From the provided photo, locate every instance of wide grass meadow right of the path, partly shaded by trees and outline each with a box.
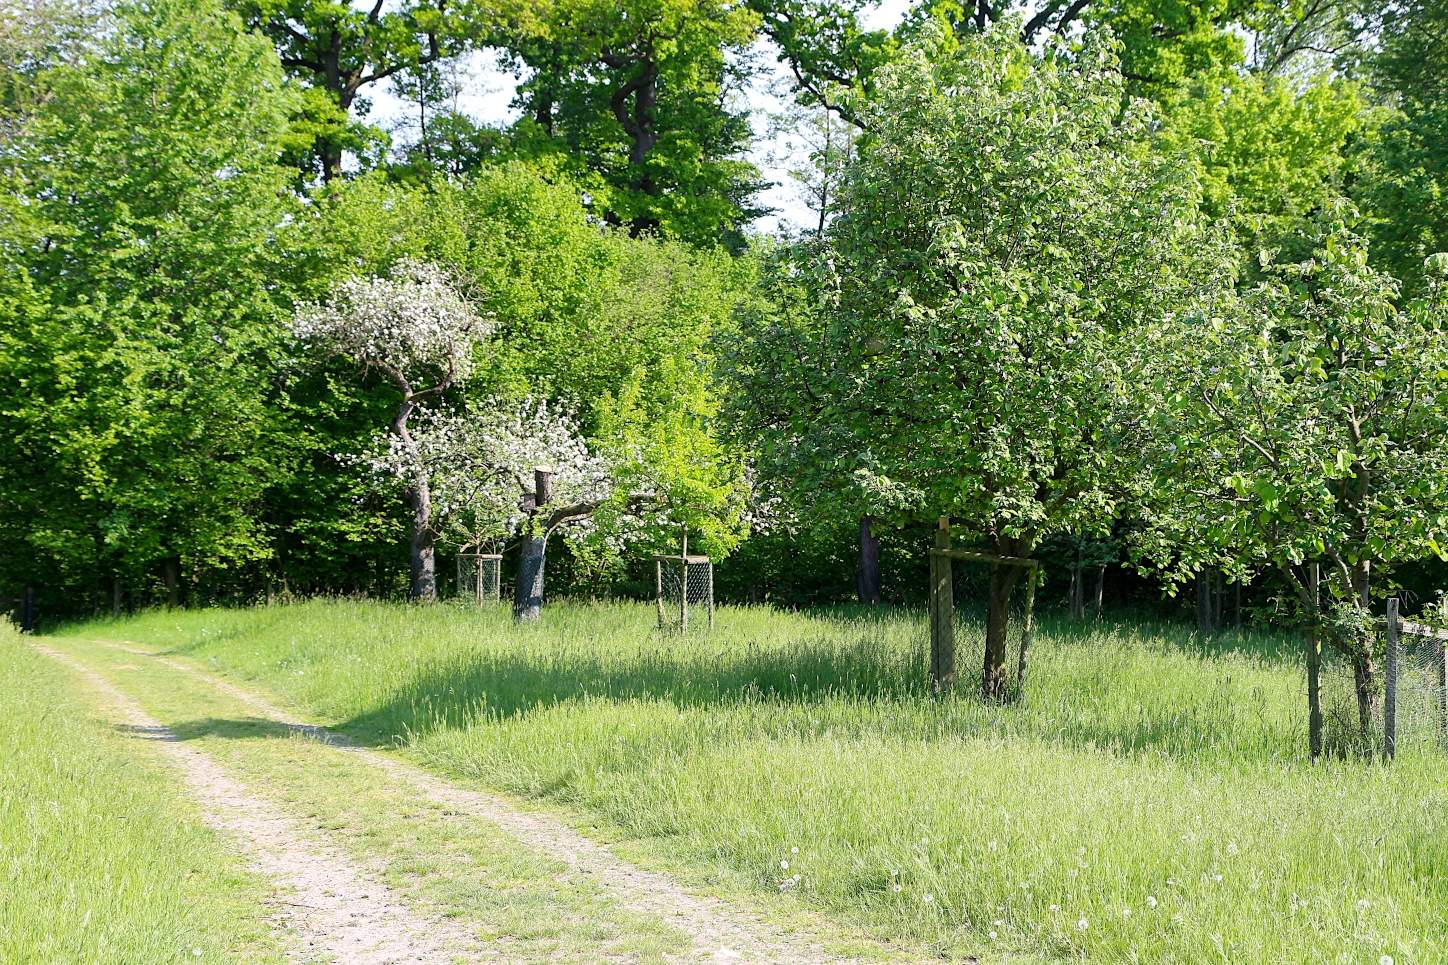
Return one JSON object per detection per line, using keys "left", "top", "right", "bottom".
{"left": 71, "top": 603, "right": 1448, "bottom": 964}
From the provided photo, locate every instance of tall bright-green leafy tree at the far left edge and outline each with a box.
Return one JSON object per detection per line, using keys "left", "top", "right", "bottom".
{"left": 0, "top": 0, "right": 292, "bottom": 605}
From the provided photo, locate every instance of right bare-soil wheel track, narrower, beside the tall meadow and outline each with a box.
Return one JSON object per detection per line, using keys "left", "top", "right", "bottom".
{"left": 68, "top": 640, "right": 857, "bottom": 965}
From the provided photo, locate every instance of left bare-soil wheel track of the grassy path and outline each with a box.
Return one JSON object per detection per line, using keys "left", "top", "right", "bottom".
{"left": 35, "top": 645, "right": 500, "bottom": 965}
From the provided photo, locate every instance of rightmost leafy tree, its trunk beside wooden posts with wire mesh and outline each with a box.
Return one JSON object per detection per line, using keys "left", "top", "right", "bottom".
{"left": 1140, "top": 225, "right": 1448, "bottom": 755}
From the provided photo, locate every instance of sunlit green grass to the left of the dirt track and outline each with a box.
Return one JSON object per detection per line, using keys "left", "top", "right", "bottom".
{"left": 0, "top": 623, "right": 282, "bottom": 965}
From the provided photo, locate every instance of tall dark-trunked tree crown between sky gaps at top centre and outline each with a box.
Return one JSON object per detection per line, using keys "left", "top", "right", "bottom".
{"left": 497, "top": 0, "right": 760, "bottom": 245}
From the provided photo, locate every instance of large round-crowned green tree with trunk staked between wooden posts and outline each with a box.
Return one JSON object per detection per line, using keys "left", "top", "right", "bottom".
{"left": 729, "top": 26, "right": 1219, "bottom": 697}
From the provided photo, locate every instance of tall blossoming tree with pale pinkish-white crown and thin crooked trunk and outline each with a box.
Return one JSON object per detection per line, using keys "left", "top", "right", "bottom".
{"left": 292, "top": 261, "right": 492, "bottom": 601}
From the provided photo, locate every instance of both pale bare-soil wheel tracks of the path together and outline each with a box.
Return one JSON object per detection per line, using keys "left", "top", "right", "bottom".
{"left": 36, "top": 640, "right": 873, "bottom": 965}
